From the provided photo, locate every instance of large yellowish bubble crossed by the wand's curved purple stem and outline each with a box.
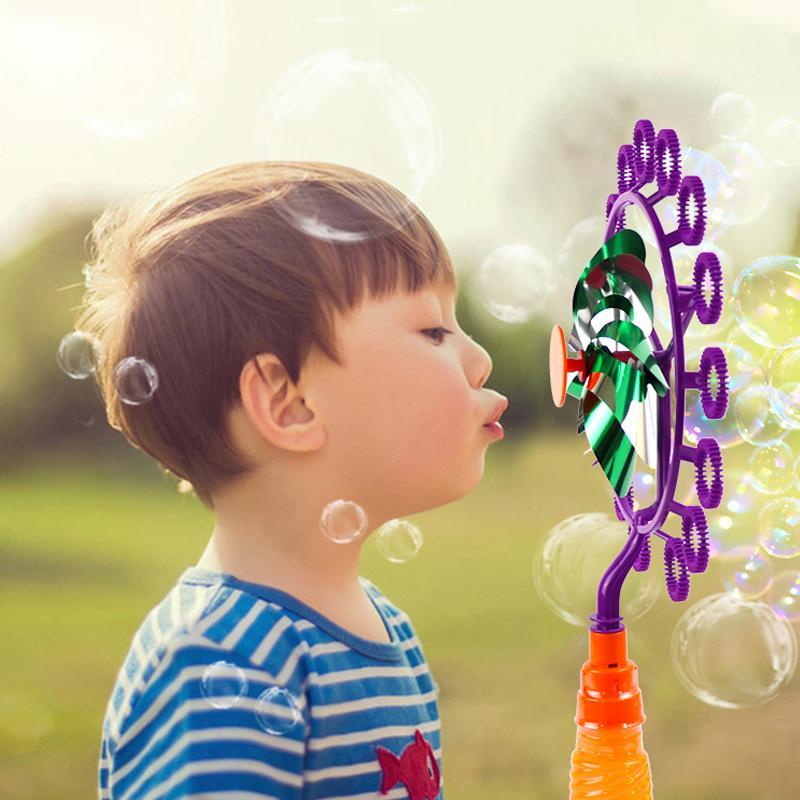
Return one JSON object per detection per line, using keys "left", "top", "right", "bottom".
{"left": 533, "top": 512, "right": 661, "bottom": 627}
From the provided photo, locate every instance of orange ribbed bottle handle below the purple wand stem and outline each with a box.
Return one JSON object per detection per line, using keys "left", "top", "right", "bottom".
{"left": 569, "top": 628, "right": 653, "bottom": 800}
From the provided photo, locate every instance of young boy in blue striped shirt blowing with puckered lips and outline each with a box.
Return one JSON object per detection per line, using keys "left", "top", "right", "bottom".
{"left": 76, "top": 162, "right": 507, "bottom": 800}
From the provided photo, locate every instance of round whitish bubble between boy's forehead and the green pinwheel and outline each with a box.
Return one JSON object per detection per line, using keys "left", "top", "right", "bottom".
{"left": 476, "top": 244, "right": 554, "bottom": 323}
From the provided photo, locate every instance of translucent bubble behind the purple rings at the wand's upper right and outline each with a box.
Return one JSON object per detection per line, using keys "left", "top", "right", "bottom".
{"left": 625, "top": 146, "right": 731, "bottom": 245}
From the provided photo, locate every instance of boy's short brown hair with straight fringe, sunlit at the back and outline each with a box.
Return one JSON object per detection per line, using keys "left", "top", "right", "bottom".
{"left": 75, "top": 161, "right": 456, "bottom": 509}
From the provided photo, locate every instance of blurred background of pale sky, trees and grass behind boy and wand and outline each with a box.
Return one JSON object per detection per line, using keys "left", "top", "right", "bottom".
{"left": 0, "top": 0, "right": 800, "bottom": 800}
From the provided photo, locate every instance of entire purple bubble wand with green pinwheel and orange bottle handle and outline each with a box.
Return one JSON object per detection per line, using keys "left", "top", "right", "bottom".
{"left": 550, "top": 119, "right": 728, "bottom": 800}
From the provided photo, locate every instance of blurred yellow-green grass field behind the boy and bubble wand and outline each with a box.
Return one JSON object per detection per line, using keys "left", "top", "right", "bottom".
{"left": 0, "top": 434, "right": 800, "bottom": 800}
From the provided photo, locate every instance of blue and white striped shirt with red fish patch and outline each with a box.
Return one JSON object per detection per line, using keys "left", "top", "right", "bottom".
{"left": 99, "top": 566, "right": 444, "bottom": 800}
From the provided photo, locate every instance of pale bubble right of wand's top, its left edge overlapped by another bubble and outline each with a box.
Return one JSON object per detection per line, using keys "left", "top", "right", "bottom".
{"left": 709, "top": 142, "right": 771, "bottom": 226}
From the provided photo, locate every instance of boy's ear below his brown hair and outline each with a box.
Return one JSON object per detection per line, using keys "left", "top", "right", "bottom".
{"left": 239, "top": 353, "right": 327, "bottom": 452}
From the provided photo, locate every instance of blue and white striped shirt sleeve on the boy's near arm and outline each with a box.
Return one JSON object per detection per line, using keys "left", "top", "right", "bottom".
{"left": 109, "top": 635, "right": 309, "bottom": 800}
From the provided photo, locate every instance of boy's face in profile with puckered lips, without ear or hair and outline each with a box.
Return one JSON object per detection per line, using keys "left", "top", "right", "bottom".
{"left": 305, "top": 286, "right": 505, "bottom": 518}
